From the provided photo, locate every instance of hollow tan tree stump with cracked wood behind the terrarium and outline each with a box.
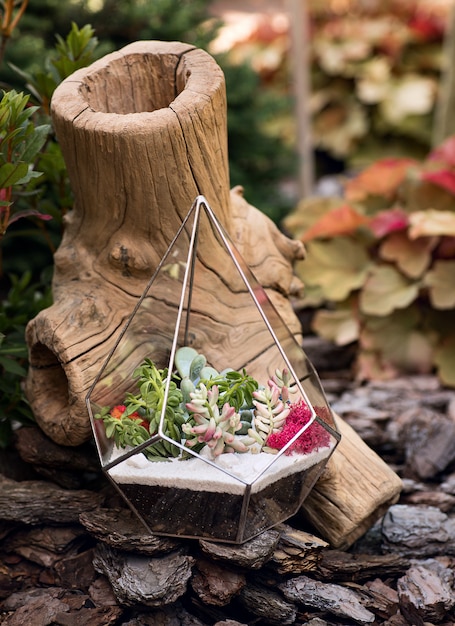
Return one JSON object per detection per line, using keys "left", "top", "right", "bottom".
{"left": 26, "top": 41, "right": 400, "bottom": 544}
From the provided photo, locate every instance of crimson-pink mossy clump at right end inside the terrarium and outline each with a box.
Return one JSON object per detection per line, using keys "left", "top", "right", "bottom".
{"left": 267, "top": 400, "right": 330, "bottom": 455}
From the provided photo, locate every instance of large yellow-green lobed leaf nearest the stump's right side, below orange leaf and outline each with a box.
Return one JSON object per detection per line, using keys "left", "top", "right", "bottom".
{"left": 299, "top": 237, "right": 370, "bottom": 301}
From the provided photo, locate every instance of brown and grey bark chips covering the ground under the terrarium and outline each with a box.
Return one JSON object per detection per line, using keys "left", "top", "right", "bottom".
{"left": 0, "top": 342, "right": 455, "bottom": 626}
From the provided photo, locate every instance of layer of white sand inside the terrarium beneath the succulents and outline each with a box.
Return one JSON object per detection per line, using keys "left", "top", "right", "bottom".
{"left": 108, "top": 446, "right": 333, "bottom": 494}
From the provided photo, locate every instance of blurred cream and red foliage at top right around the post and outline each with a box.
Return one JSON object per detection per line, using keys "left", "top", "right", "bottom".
{"left": 216, "top": 0, "right": 454, "bottom": 178}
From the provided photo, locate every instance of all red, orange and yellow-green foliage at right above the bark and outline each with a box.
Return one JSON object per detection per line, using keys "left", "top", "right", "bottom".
{"left": 211, "top": 0, "right": 455, "bottom": 387}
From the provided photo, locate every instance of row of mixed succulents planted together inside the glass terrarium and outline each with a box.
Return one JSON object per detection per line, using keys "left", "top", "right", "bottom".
{"left": 95, "top": 346, "right": 324, "bottom": 460}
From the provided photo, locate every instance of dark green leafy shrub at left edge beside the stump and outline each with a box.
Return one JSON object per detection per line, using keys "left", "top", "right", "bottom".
{"left": 0, "top": 24, "right": 100, "bottom": 447}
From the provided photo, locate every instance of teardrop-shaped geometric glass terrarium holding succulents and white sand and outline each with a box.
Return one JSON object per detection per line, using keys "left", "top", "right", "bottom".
{"left": 87, "top": 196, "right": 340, "bottom": 543}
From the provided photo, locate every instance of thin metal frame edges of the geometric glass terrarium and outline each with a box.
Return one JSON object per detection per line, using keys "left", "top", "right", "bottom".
{"left": 86, "top": 196, "right": 340, "bottom": 543}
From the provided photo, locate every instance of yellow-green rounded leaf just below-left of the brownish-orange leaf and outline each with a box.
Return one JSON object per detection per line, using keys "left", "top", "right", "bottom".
{"left": 359, "top": 265, "right": 419, "bottom": 316}
